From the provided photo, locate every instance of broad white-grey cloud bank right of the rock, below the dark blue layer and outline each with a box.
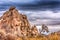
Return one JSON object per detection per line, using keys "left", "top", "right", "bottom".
{"left": 19, "top": 11, "right": 60, "bottom": 25}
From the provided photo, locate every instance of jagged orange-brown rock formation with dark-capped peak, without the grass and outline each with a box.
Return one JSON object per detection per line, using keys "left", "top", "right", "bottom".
{"left": 0, "top": 6, "right": 38, "bottom": 39}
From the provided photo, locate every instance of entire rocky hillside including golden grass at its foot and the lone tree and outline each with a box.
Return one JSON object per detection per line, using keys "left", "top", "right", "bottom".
{"left": 0, "top": 6, "right": 60, "bottom": 40}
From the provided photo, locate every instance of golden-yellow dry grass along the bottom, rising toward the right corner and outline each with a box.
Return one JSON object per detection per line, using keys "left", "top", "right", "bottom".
{"left": 17, "top": 33, "right": 60, "bottom": 40}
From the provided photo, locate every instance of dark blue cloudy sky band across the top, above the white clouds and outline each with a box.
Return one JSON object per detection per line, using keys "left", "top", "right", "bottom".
{"left": 0, "top": 0, "right": 60, "bottom": 10}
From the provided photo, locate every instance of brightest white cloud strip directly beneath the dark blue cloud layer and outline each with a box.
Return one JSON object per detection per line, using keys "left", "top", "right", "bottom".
{"left": 21, "top": 11, "right": 60, "bottom": 19}
